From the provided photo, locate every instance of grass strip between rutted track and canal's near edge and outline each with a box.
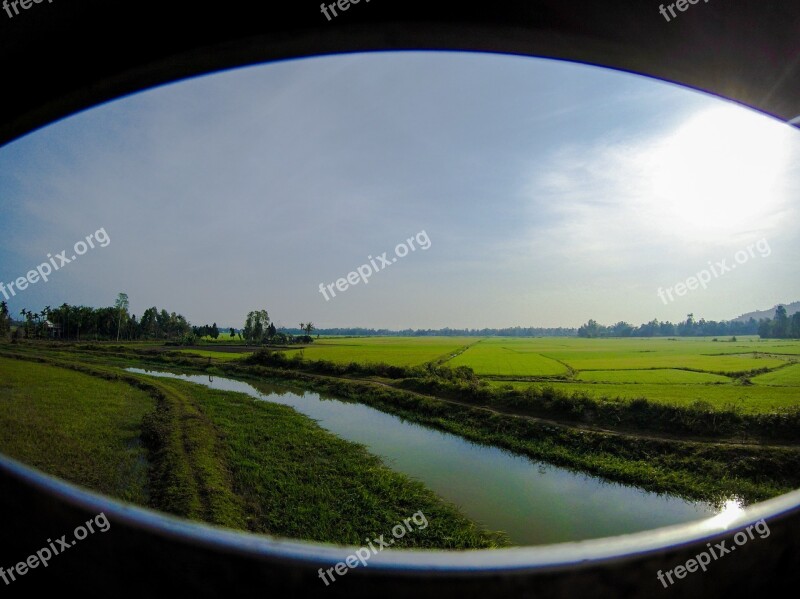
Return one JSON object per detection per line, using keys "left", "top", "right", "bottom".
{"left": 165, "top": 380, "right": 506, "bottom": 549}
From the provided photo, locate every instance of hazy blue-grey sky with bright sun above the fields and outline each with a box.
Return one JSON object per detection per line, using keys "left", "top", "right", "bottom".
{"left": 0, "top": 52, "right": 800, "bottom": 328}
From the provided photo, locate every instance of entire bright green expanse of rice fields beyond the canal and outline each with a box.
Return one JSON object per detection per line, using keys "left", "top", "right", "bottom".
{"left": 245, "top": 337, "right": 800, "bottom": 412}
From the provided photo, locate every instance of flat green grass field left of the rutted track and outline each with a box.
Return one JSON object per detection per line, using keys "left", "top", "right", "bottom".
{"left": 0, "top": 358, "right": 155, "bottom": 504}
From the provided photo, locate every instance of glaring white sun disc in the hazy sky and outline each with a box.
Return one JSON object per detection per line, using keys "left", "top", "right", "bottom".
{"left": 650, "top": 105, "right": 796, "bottom": 233}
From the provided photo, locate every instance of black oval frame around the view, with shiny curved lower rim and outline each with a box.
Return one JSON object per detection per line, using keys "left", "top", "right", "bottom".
{"left": 0, "top": 0, "right": 800, "bottom": 598}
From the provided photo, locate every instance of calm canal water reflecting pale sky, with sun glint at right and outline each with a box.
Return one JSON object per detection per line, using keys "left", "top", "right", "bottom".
{"left": 130, "top": 369, "right": 720, "bottom": 545}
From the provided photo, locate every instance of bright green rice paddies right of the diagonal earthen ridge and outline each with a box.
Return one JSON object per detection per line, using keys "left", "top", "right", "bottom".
{"left": 449, "top": 337, "right": 800, "bottom": 413}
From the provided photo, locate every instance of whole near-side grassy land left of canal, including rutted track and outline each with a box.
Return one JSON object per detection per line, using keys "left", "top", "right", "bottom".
{"left": 0, "top": 347, "right": 500, "bottom": 549}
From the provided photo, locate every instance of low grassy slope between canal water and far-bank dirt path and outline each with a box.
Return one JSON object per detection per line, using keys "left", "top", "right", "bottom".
{"left": 221, "top": 363, "right": 800, "bottom": 503}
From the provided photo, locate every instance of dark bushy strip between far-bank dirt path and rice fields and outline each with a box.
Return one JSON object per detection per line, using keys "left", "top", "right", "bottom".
{"left": 238, "top": 350, "right": 800, "bottom": 443}
